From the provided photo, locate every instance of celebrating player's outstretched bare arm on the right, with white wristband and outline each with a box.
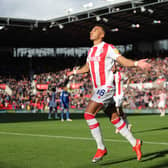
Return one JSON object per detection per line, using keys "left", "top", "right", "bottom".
{"left": 117, "top": 56, "right": 151, "bottom": 70}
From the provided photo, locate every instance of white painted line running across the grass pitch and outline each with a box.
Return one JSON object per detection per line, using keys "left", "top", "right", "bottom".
{"left": 0, "top": 132, "right": 168, "bottom": 145}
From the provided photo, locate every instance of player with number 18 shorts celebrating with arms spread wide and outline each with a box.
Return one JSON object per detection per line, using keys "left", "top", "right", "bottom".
{"left": 68, "top": 25, "right": 151, "bottom": 163}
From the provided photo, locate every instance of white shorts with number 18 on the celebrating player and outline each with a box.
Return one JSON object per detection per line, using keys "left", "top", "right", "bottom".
{"left": 91, "top": 85, "right": 115, "bottom": 105}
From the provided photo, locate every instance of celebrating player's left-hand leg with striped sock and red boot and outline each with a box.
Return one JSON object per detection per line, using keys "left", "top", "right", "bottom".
{"left": 84, "top": 100, "right": 107, "bottom": 163}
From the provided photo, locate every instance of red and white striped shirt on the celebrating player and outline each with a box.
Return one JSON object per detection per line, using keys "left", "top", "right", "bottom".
{"left": 87, "top": 42, "right": 120, "bottom": 89}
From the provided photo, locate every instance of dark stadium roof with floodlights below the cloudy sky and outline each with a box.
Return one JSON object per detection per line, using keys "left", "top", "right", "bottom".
{"left": 0, "top": 0, "right": 168, "bottom": 47}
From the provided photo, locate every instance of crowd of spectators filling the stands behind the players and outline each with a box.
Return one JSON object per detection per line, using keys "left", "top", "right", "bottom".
{"left": 0, "top": 53, "right": 168, "bottom": 112}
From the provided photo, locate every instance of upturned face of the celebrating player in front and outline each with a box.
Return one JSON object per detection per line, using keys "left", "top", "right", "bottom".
{"left": 90, "top": 26, "right": 104, "bottom": 41}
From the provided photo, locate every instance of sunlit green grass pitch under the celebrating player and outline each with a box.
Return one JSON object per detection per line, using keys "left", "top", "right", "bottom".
{"left": 0, "top": 115, "right": 168, "bottom": 168}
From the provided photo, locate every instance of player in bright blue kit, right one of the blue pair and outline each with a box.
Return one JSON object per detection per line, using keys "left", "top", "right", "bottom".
{"left": 60, "top": 86, "right": 72, "bottom": 121}
